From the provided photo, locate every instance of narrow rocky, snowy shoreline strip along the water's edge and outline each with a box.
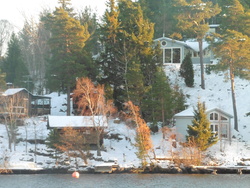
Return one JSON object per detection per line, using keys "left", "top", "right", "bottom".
{"left": 0, "top": 166, "right": 250, "bottom": 175}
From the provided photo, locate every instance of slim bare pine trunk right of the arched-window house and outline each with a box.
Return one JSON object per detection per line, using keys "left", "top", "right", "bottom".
{"left": 230, "top": 62, "right": 239, "bottom": 131}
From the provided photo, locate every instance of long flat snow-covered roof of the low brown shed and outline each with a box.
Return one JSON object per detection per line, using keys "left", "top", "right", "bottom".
{"left": 48, "top": 116, "right": 108, "bottom": 128}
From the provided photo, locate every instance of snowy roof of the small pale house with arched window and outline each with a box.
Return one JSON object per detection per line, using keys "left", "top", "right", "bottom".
{"left": 174, "top": 108, "right": 233, "bottom": 118}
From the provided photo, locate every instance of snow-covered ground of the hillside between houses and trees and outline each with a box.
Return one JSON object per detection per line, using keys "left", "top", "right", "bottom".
{"left": 0, "top": 66, "right": 250, "bottom": 168}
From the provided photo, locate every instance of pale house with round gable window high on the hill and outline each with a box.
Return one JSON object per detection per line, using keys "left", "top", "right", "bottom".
{"left": 154, "top": 36, "right": 213, "bottom": 65}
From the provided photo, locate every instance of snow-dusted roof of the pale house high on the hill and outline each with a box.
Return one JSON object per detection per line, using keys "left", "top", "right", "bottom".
{"left": 154, "top": 37, "right": 209, "bottom": 52}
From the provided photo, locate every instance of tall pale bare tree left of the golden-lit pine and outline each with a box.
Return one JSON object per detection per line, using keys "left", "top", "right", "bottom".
{"left": 19, "top": 9, "right": 49, "bottom": 94}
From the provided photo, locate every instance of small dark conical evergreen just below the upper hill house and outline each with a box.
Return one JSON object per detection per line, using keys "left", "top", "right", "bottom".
{"left": 180, "top": 53, "right": 194, "bottom": 87}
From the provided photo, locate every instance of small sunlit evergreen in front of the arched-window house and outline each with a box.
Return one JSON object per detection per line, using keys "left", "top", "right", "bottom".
{"left": 187, "top": 102, "right": 218, "bottom": 151}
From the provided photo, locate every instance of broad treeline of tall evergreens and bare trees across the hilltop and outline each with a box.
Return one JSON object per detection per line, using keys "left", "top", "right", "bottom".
{"left": 0, "top": 0, "right": 250, "bottom": 124}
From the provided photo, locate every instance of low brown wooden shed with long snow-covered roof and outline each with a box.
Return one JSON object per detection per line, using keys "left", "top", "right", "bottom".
{"left": 47, "top": 116, "right": 108, "bottom": 145}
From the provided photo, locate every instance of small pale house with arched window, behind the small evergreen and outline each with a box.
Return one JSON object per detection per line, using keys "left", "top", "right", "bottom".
{"left": 174, "top": 108, "right": 233, "bottom": 141}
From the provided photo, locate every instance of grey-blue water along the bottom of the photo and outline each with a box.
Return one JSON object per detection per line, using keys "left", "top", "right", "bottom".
{"left": 0, "top": 174, "right": 250, "bottom": 188}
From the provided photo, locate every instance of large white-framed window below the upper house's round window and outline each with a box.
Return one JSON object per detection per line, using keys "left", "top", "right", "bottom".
{"left": 165, "top": 48, "right": 181, "bottom": 63}
